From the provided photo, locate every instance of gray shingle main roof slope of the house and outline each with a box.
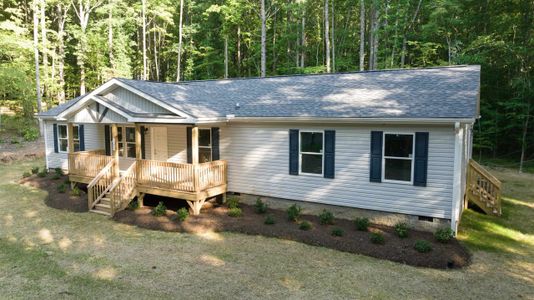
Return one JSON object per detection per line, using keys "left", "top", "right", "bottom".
{"left": 38, "top": 66, "right": 480, "bottom": 118}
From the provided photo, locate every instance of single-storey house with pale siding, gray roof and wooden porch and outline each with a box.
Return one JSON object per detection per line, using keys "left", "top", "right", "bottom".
{"left": 39, "top": 66, "right": 502, "bottom": 230}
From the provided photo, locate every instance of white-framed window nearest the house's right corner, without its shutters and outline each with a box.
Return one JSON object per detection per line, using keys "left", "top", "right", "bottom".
{"left": 382, "top": 133, "right": 414, "bottom": 183}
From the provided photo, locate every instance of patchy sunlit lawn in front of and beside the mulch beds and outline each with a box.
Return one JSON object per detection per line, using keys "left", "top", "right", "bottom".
{"left": 0, "top": 160, "right": 534, "bottom": 299}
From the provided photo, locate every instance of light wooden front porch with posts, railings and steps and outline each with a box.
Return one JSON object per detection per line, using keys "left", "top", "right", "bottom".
{"left": 68, "top": 123, "right": 227, "bottom": 216}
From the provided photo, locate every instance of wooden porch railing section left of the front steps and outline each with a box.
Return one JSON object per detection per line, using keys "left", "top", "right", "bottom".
{"left": 69, "top": 150, "right": 113, "bottom": 177}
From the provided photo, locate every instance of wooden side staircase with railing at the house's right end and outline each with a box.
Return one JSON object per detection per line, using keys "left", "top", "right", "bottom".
{"left": 465, "top": 160, "right": 502, "bottom": 216}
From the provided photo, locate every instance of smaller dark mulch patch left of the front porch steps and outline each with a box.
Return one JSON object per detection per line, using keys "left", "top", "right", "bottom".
{"left": 19, "top": 172, "right": 88, "bottom": 212}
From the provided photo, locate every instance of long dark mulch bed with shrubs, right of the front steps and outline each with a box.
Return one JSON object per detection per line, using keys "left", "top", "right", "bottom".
{"left": 114, "top": 202, "right": 470, "bottom": 269}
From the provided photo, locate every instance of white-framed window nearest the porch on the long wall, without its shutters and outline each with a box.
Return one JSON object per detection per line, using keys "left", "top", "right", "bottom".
{"left": 299, "top": 131, "right": 324, "bottom": 175}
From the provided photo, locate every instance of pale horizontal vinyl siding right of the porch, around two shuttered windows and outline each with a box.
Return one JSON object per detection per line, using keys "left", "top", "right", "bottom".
{"left": 220, "top": 124, "right": 454, "bottom": 218}
